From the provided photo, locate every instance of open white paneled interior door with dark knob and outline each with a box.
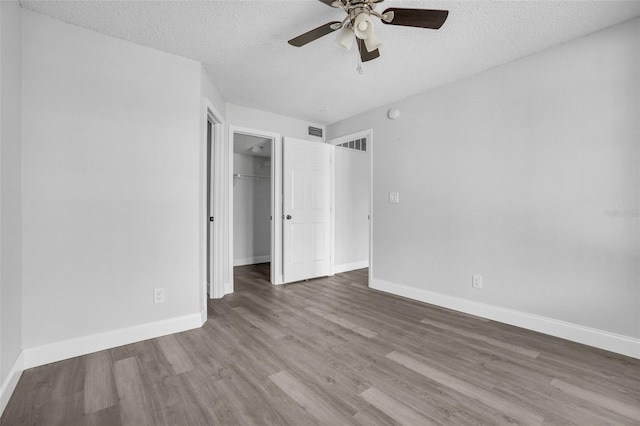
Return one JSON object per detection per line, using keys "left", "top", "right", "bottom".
{"left": 282, "top": 138, "right": 333, "bottom": 282}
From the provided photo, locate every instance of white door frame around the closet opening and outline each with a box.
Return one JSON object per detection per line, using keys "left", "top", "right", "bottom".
{"left": 226, "top": 126, "right": 283, "bottom": 293}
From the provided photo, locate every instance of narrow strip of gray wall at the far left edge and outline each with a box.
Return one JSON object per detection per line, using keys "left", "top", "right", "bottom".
{"left": 0, "top": 1, "right": 22, "bottom": 388}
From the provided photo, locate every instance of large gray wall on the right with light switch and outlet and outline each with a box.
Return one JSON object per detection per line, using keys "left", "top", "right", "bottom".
{"left": 328, "top": 19, "right": 640, "bottom": 338}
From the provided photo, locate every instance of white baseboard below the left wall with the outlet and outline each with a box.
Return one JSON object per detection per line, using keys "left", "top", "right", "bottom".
{"left": 23, "top": 310, "right": 207, "bottom": 369}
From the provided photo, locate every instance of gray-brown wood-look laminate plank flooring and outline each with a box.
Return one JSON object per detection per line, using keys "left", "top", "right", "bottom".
{"left": 0, "top": 264, "right": 640, "bottom": 426}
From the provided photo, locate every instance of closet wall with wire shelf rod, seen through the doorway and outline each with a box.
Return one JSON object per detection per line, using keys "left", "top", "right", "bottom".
{"left": 233, "top": 154, "right": 271, "bottom": 266}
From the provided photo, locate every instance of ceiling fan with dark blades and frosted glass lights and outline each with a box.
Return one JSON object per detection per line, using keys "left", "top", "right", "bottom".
{"left": 289, "top": 0, "right": 449, "bottom": 62}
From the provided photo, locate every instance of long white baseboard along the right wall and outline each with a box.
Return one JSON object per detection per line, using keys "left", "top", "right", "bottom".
{"left": 370, "top": 279, "right": 640, "bottom": 359}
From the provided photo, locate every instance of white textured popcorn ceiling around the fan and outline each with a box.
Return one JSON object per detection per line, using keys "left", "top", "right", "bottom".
{"left": 22, "top": 0, "right": 640, "bottom": 124}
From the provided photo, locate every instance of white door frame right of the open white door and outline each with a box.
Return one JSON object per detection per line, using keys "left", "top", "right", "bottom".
{"left": 327, "top": 129, "right": 373, "bottom": 287}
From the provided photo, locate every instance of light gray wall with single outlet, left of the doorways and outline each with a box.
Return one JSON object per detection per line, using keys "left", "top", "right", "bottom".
{"left": 22, "top": 11, "right": 202, "bottom": 348}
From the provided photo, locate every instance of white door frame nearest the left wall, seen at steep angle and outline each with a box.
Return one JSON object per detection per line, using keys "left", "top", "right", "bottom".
{"left": 205, "top": 98, "right": 225, "bottom": 304}
